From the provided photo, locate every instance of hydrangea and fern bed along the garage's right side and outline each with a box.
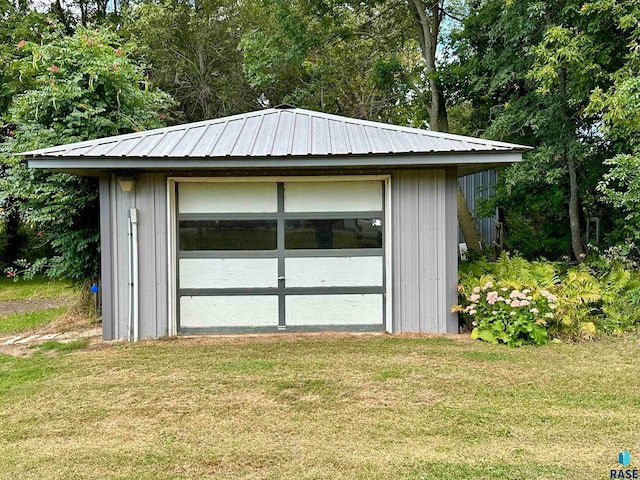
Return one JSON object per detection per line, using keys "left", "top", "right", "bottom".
{"left": 452, "top": 253, "right": 640, "bottom": 346}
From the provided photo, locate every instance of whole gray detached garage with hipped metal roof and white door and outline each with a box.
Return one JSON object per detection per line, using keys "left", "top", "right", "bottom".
{"left": 25, "top": 105, "right": 526, "bottom": 340}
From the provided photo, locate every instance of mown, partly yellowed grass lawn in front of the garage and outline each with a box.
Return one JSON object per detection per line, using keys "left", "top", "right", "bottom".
{"left": 0, "top": 335, "right": 640, "bottom": 480}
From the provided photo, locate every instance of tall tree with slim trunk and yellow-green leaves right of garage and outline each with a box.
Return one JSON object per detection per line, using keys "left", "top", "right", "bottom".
{"left": 450, "top": 0, "right": 626, "bottom": 261}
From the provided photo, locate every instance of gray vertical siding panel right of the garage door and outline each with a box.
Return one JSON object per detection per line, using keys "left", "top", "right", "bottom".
{"left": 391, "top": 169, "right": 458, "bottom": 333}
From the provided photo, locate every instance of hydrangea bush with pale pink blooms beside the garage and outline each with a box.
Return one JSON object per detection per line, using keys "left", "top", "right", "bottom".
{"left": 453, "top": 281, "right": 558, "bottom": 347}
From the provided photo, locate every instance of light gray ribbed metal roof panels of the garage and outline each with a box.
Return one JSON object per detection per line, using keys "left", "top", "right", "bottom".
{"left": 22, "top": 105, "right": 529, "bottom": 160}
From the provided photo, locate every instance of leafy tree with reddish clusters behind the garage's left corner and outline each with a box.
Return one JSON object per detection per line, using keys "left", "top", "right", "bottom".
{"left": 0, "top": 25, "right": 171, "bottom": 280}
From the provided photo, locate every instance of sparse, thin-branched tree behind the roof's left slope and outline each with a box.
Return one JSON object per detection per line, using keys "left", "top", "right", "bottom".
{"left": 123, "top": 0, "right": 258, "bottom": 121}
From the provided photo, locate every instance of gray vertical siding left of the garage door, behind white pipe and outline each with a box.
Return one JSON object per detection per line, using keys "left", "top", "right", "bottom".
{"left": 100, "top": 173, "right": 168, "bottom": 339}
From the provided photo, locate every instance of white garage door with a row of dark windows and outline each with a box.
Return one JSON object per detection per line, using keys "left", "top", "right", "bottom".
{"left": 176, "top": 180, "right": 385, "bottom": 333}
